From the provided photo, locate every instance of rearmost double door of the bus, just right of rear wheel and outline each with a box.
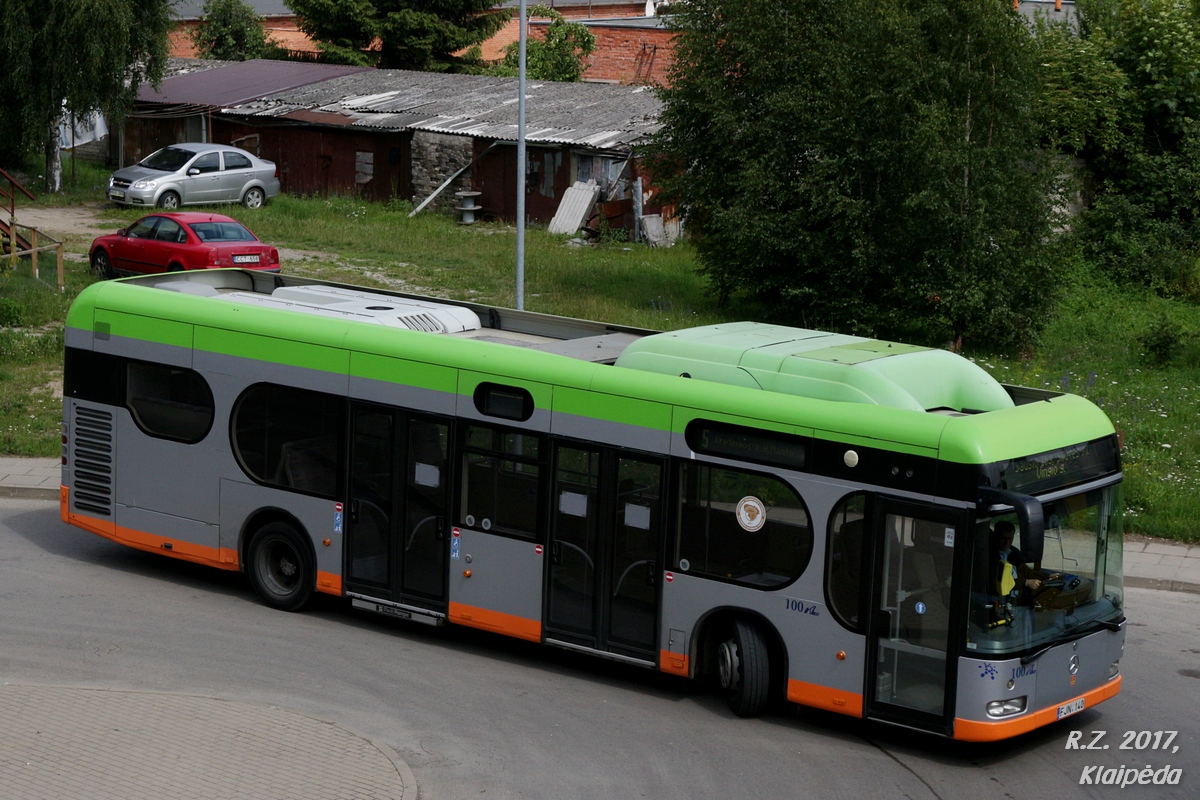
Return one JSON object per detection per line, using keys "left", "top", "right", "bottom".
{"left": 347, "top": 405, "right": 450, "bottom": 612}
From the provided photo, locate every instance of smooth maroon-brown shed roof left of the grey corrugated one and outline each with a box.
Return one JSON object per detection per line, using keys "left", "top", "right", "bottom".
{"left": 138, "top": 60, "right": 371, "bottom": 108}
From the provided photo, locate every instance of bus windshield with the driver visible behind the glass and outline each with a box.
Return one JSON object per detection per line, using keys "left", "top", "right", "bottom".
{"left": 966, "top": 487, "right": 1123, "bottom": 655}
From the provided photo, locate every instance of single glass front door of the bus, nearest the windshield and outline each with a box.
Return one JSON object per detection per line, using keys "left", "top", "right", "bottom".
{"left": 865, "top": 499, "right": 970, "bottom": 734}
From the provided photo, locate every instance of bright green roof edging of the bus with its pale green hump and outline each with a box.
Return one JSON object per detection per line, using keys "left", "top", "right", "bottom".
{"left": 66, "top": 270, "right": 1112, "bottom": 463}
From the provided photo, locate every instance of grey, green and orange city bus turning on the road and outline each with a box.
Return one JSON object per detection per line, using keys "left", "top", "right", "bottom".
{"left": 60, "top": 270, "right": 1126, "bottom": 741}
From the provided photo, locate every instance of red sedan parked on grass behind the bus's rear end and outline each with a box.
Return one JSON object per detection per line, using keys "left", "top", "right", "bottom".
{"left": 91, "top": 211, "right": 280, "bottom": 278}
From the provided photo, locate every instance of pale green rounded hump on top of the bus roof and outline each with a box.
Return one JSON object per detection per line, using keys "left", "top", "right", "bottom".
{"left": 617, "top": 323, "right": 1014, "bottom": 413}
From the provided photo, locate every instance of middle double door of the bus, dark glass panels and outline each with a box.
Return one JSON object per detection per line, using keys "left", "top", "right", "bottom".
{"left": 546, "top": 445, "right": 664, "bottom": 661}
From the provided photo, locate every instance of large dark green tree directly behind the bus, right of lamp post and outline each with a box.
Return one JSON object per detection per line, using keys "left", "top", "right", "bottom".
{"left": 650, "top": 0, "right": 1055, "bottom": 348}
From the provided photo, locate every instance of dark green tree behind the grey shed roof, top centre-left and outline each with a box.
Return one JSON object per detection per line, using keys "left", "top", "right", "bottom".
{"left": 287, "top": 0, "right": 510, "bottom": 72}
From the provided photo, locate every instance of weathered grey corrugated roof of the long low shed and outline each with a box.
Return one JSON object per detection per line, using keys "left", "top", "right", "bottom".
{"left": 222, "top": 70, "right": 661, "bottom": 150}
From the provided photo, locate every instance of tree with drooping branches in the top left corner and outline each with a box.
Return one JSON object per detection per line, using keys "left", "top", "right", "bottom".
{"left": 0, "top": 0, "right": 174, "bottom": 192}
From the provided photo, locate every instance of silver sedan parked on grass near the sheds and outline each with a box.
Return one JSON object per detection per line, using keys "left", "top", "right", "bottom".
{"left": 104, "top": 143, "right": 280, "bottom": 209}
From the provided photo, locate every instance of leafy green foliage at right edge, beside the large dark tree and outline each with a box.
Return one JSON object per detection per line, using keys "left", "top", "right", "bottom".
{"left": 1070, "top": 0, "right": 1200, "bottom": 292}
